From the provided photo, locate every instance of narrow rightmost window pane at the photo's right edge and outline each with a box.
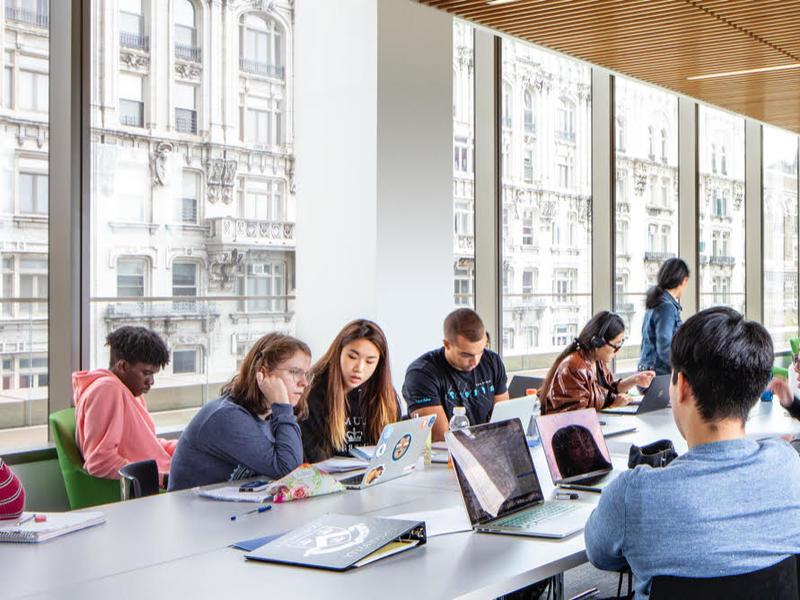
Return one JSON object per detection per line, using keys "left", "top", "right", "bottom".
{"left": 763, "top": 126, "right": 800, "bottom": 351}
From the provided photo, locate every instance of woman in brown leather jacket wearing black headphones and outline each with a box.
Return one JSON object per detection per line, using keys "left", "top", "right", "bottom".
{"left": 539, "top": 310, "right": 655, "bottom": 414}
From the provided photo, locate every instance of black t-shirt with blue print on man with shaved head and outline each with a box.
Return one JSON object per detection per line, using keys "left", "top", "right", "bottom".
{"left": 403, "top": 348, "right": 506, "bottom": 425}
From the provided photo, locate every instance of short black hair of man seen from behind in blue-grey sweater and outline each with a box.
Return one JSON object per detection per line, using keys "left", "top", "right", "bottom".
{"left": 670, "top": 306, "right": 773, "bottom": 422}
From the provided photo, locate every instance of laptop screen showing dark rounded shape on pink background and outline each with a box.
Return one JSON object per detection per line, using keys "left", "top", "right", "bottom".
{"left": 536, "top": 408, "right": 612, "bottom": 483}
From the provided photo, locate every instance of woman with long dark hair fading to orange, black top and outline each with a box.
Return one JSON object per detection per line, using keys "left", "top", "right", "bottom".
{"left": 300, "top": 319, "right": 400, "bottom": 462}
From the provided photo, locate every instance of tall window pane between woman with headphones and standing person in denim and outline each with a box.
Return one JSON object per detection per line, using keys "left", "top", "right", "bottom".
{"left": 614, "top": 77, "right": 678, "bottom": 369}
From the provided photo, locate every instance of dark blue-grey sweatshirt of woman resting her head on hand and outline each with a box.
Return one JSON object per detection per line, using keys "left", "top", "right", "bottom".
{"left": 169, "top": 396, "right": 303, "bottom": 491}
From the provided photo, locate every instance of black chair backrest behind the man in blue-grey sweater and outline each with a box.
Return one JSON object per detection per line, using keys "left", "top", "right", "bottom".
{"left": 650, "top": 556, "right": 800, "bottom": 600}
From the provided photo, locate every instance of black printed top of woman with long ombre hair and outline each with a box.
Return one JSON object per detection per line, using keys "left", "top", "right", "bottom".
{"left": 300, "top": 375, "right": 400, "bottom": 462}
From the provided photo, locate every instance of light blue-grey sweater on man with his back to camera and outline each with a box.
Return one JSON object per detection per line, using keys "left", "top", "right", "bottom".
{"left": 584, "top": 439, "right": 800, "bottom": 600}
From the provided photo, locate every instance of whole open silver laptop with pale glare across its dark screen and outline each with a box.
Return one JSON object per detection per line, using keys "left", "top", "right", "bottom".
{"left": 445, "top": 419, "right": 593, "bottom": 538}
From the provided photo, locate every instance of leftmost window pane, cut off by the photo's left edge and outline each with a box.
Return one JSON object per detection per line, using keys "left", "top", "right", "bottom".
{"left": 0, "top": 0, "right": 50, "bottom": 449}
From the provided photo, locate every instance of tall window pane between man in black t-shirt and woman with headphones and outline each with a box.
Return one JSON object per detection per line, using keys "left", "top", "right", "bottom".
{"left": 501, "top": 40, "right": 592, "bottom": 371}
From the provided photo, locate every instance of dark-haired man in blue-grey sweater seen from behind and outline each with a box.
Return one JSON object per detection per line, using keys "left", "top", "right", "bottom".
{"left": 584, "top": 307, "right": 800, "bottom": 600}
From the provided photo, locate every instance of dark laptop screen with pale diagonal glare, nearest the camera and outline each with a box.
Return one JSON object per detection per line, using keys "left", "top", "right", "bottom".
{"left": 446, "top": 419, "right": 544, "bottom": 525}
